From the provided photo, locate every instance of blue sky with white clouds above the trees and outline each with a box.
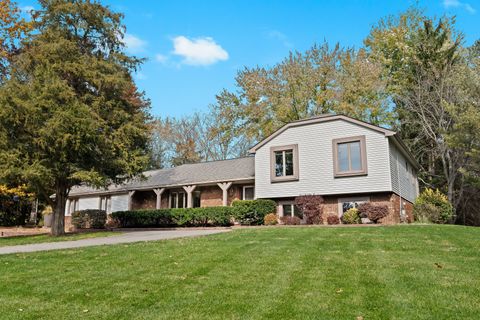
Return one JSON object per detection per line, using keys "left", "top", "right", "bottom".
{"left": 20, "top": 0, "right": 480, "bottom": 116}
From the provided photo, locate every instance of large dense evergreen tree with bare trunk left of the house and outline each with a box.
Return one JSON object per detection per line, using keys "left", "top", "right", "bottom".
{"left": 0, "top": 0, "right": 149, "bottom": 235}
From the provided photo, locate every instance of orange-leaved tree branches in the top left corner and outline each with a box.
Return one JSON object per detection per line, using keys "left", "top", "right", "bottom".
{"left": 0, "top": 0, "right": 32, "bottom": 83}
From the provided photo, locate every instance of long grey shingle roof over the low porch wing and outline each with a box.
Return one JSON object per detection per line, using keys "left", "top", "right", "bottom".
{"left": 70, "top": 157, "right": 255, "bottom": 195}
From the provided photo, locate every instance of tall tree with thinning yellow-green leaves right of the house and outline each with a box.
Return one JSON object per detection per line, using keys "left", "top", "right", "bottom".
{"left": 365, "top": 9, "right": 480, "bottom": 221}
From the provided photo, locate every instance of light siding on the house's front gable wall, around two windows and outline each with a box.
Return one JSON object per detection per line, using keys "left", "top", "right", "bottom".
{"left": 255, "top": 119, "right": 392, "bottom": 198}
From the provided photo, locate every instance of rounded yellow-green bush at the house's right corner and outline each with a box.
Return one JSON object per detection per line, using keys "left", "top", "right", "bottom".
{"left": 413, "top": 188, "right": 454, "bottom": 223}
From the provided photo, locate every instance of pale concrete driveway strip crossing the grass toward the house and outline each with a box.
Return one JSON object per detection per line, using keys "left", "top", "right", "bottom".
{"left": 0, "top": 229, "right": 230, "bottom": 255}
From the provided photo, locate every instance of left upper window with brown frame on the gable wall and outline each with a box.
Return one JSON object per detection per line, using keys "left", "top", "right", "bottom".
{"left": 270, "top": 144, "right": 298, "bottom": 182}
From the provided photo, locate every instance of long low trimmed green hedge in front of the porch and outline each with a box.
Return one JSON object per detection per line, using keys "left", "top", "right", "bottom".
{"left": 112, "top": 207, "right": 234, "bottom": 228}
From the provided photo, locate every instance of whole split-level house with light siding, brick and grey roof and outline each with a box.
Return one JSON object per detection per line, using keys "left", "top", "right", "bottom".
{"left": 66, "top": 115, "right": 419, "bottom": 223}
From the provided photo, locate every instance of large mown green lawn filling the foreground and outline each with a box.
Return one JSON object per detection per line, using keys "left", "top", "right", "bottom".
{"left": 0, "top": 226, "right": 480, "bottom": 320}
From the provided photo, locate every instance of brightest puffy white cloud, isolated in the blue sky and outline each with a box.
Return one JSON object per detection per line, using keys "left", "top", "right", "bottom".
{"left": 173, "top": 36, "right": 228, "bottom": 66}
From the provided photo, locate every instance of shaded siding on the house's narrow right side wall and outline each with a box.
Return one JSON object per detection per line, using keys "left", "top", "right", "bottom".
{"left": 390, "top": 142, "right": 418, "bottom": 202}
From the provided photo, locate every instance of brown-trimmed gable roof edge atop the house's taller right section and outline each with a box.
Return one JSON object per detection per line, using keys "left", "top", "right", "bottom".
{"left": 249, "top": 114, "right": 420, "bottom": 169}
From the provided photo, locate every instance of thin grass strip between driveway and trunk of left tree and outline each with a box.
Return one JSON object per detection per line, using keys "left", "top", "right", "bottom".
{"left": 0, "top": 231, "right": 120, "bottom": 247}
